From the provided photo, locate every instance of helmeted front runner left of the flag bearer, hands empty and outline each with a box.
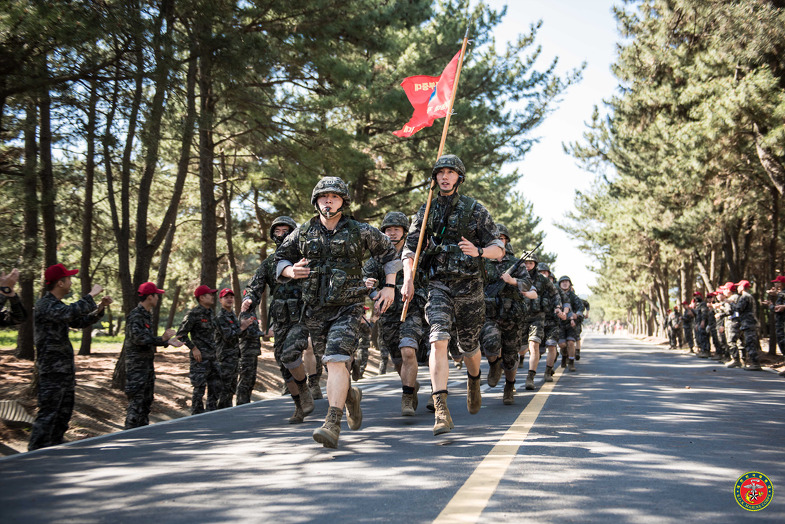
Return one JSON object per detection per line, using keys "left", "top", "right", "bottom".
{"left": 275, "top": 177, "right": 401, "bottom": 448}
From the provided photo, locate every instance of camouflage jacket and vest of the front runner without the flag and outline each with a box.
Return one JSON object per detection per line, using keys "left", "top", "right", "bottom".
{"left": 275, "top": 216, "right": 401, "bottom": 306}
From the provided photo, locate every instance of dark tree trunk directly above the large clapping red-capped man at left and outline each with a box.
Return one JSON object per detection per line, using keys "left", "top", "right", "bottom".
{"left": 38, "top": 60, "right": 57, "bottom": 267}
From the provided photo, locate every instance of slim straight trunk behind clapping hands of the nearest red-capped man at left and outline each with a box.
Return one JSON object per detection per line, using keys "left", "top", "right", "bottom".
{"left": 79, "top": 79, "right": 98, "bottom": 355}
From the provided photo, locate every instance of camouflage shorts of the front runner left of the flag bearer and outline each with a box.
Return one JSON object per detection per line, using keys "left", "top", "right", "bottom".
{"left": 298, "top": 303, "right": 365, "bottom": 369}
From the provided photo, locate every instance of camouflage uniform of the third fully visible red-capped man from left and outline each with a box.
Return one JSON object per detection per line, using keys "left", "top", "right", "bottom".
{"left": 176, "top": 305, "right": 221, "bottom": 415}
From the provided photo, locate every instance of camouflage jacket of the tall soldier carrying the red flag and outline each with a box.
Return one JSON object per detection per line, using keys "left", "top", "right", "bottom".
{"left": 402, "top": 192, "right": 504, "bottom": 281}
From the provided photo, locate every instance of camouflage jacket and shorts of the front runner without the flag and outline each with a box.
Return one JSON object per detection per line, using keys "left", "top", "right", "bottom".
{"left": 275, "top": 216, "right": 400, "bottom": 369}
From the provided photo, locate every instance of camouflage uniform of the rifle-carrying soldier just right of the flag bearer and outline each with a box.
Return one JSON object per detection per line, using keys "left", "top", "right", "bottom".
{"left": 480, "top": 244, "right": 531, "bottom": 371}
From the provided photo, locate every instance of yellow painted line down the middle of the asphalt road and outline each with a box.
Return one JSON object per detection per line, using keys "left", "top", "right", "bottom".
{"left": 433, "top": 368, "right": 564, "bottom": 524}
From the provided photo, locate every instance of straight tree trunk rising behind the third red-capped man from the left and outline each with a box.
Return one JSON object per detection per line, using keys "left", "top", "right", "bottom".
{"left": 197, "top": 18, "right": 218, "bottom": 288}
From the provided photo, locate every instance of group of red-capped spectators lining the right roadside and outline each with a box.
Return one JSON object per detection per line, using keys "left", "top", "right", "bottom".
{"left": 666, "top": 275, "right": 785, "bottom": 376}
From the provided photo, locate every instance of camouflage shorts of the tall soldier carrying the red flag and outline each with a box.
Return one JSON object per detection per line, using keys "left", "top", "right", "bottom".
{"left": 425, "top": 279, "right": 485, "bottom": 357}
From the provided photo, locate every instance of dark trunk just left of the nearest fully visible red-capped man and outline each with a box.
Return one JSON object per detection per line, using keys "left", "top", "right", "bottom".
{"left": 14, "top": 100, "right": 41, "bottom": 360}
